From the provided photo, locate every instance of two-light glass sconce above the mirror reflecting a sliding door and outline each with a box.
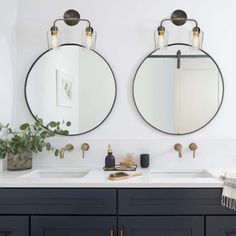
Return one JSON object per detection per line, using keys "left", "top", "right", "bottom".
{"left": 154, "top": 10, "right": 203, "bottom": 49}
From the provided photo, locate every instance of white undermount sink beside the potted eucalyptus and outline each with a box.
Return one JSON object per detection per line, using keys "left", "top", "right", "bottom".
{"left": 20, "top": 169, "right": 90, "bottom": 179}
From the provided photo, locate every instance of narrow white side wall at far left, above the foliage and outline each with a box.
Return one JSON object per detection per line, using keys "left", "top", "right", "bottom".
{"left": 0, "top": 0, "right": 17, "bottom": 124}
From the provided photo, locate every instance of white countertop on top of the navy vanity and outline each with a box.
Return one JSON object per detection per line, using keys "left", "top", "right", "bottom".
{"left": 0, "top": 169, "right": 229, "bottom": 188}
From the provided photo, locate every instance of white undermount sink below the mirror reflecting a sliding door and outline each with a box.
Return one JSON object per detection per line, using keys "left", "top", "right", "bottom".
{"left": 150, "top": 170, "right": 214, "bottom": 179}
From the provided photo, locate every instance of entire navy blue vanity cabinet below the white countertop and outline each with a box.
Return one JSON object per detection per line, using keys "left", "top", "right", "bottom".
{"left": 0, "top": 188, "right": 236, "bottom": 236}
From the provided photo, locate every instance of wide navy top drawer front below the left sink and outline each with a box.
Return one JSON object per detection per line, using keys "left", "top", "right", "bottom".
{"left": 0, "top": 188, "right": 117, "bottom": 215}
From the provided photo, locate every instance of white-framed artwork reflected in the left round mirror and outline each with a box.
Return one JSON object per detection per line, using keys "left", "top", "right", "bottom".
{"left": 56, "top": 69, "right": 74, "bottom": 107}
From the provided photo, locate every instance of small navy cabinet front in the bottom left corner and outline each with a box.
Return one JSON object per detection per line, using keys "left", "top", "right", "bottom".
{"left": 0, "top": 216, "right": 30, "bottom": 236}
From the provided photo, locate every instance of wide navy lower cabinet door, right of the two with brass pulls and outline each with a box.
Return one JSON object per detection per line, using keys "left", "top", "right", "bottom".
{"left": 119, "top": 216, "right": 204, "bottom": 236}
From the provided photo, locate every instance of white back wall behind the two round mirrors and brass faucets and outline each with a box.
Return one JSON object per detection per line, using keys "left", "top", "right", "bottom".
{"left": 3, "top": 0, "right": 236, "bottom": 168}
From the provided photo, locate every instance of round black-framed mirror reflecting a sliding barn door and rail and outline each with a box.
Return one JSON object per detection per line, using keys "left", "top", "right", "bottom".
{"left": 133, "top": 44, "right": 224, "bottom": 134}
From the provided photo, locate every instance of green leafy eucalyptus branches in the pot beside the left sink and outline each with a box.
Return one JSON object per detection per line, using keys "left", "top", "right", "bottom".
{"left": 0, "top": 118, "right": 71, "bottom": 158}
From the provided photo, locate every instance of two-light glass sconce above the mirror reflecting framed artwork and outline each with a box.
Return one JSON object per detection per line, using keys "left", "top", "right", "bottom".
{"left": 48, "top": 9, "right": 97, "bottom": 49}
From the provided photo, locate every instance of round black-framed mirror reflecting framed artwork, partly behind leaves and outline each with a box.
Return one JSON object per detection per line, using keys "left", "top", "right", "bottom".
{"left": 25, "top": 44, "right": 116, "bottom": 135}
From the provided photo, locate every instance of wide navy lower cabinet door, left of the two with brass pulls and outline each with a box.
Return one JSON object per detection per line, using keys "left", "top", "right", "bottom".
{"left": 31, "top": 216, "right": 117, "bottom": 236}
